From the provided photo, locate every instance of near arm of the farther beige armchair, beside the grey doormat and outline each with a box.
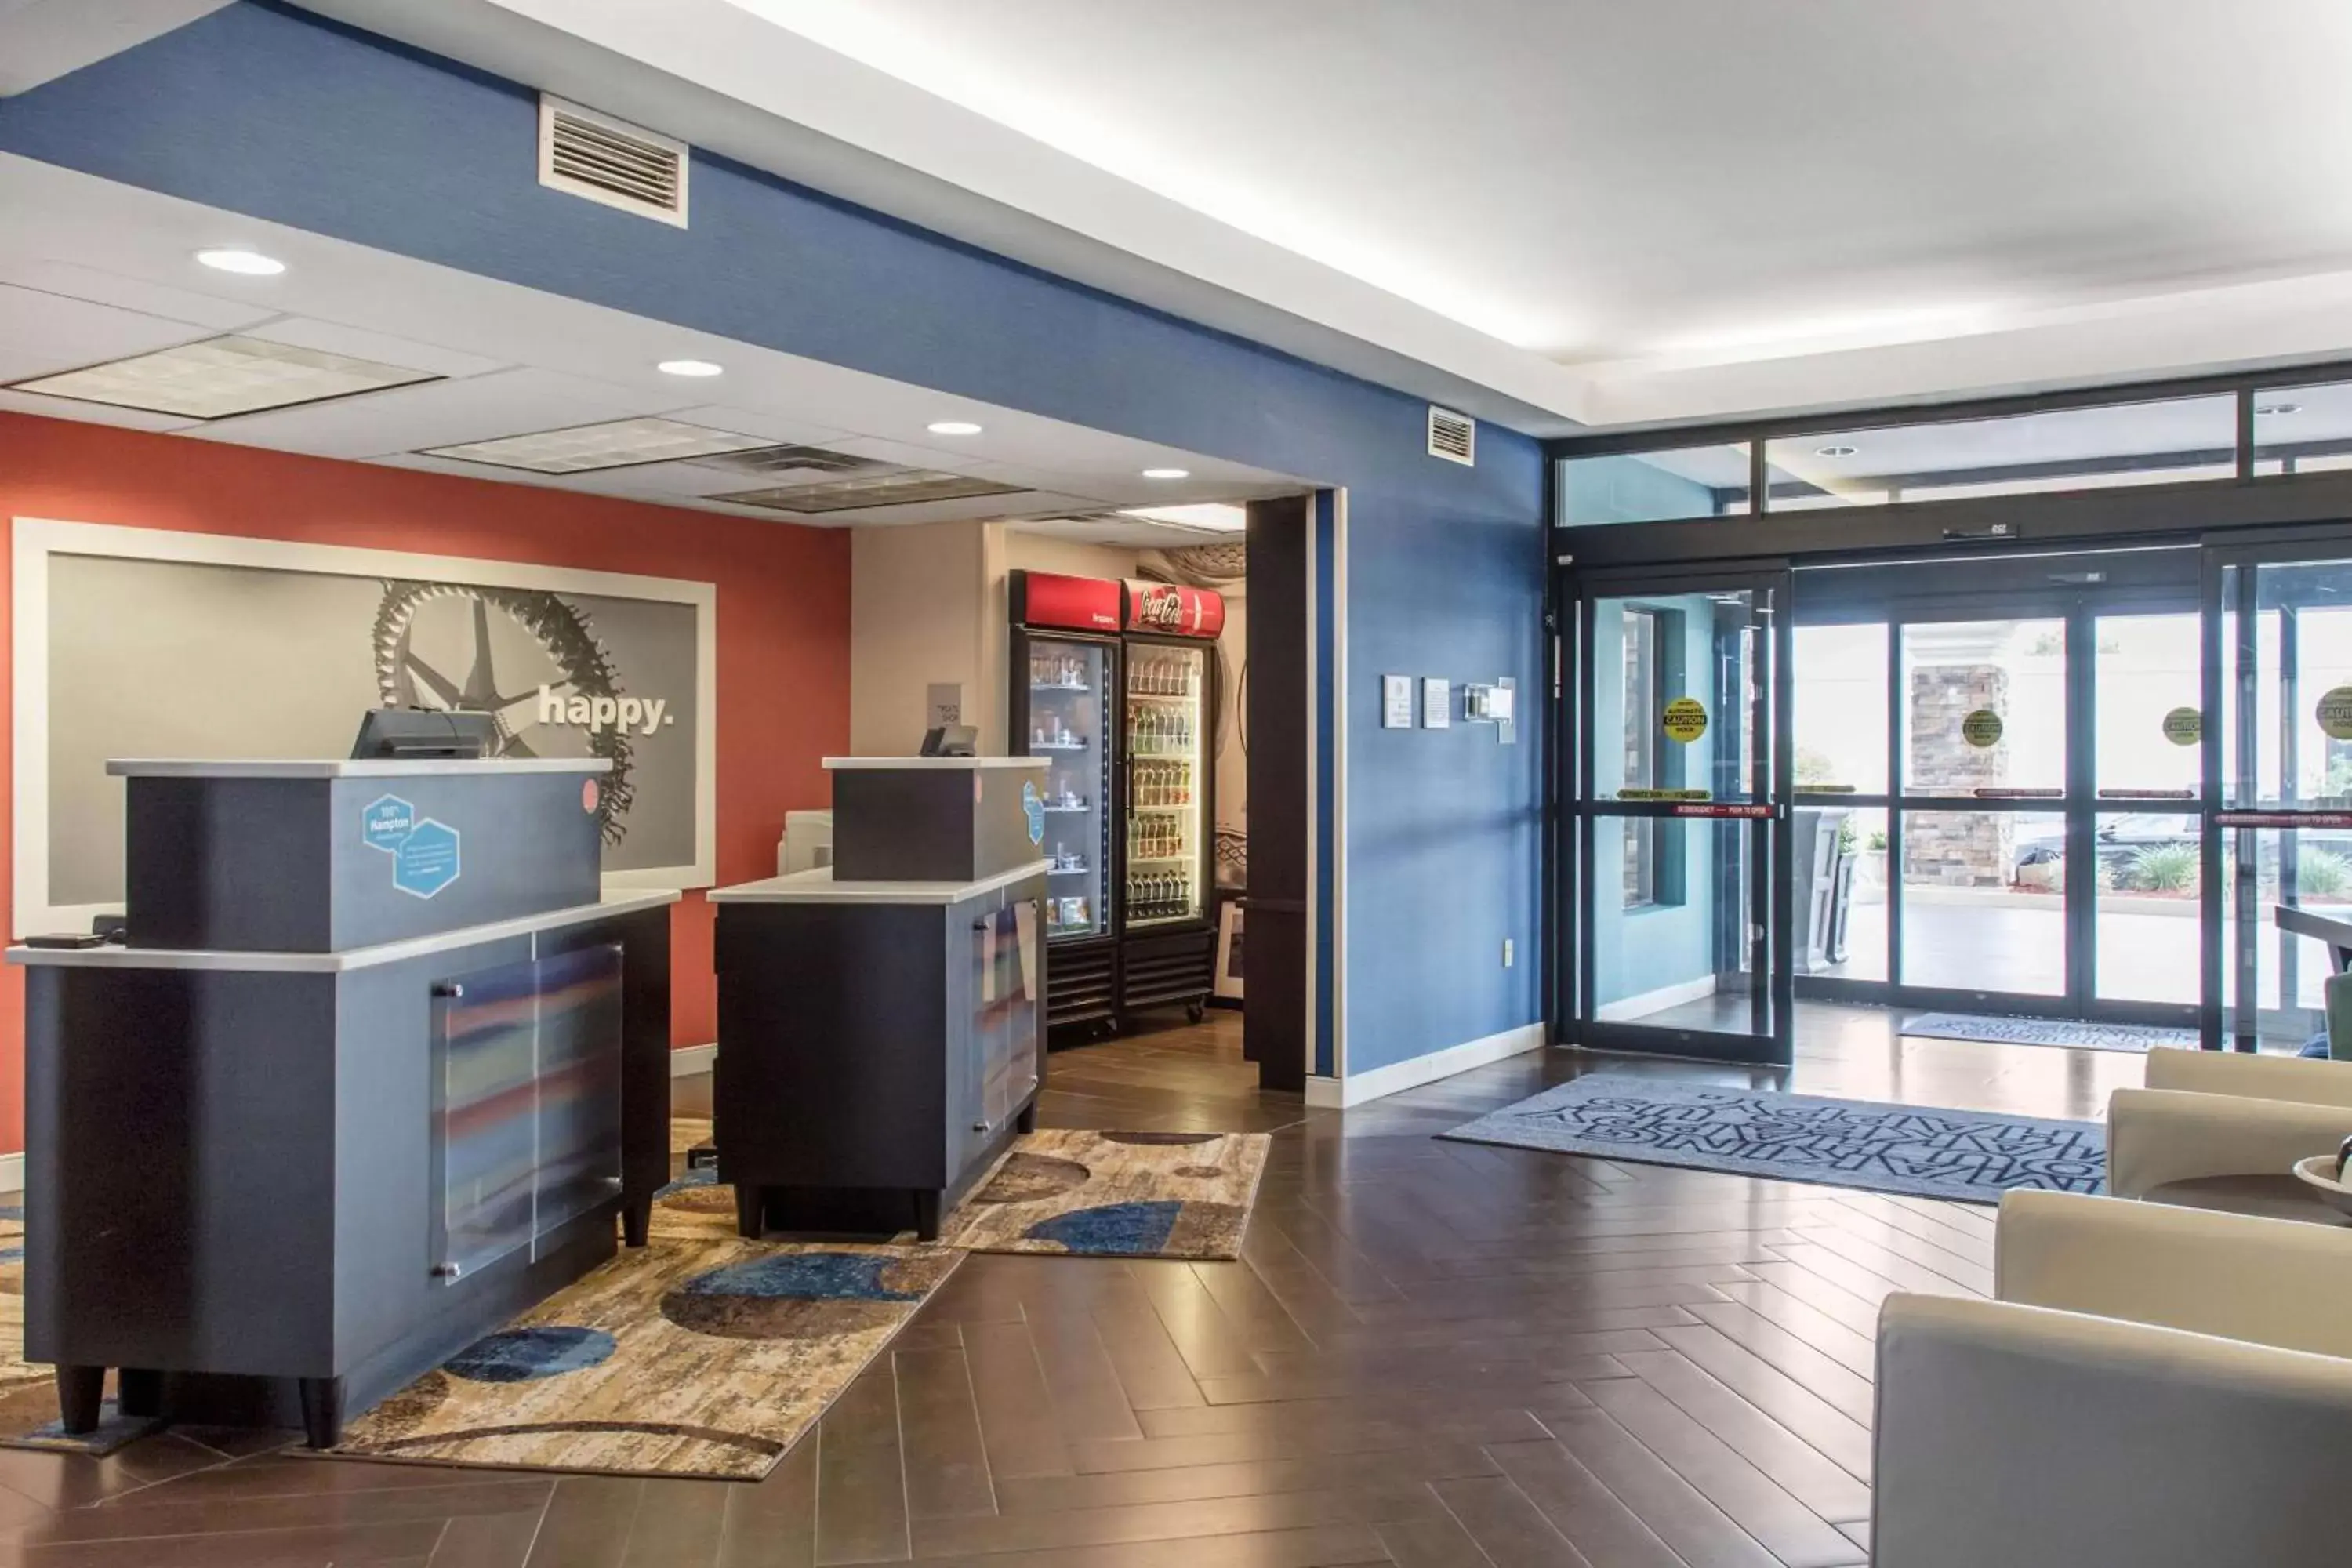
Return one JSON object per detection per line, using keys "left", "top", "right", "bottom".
{"left": 2107, "top": 1088, "right": 2352, "bottom": 1199}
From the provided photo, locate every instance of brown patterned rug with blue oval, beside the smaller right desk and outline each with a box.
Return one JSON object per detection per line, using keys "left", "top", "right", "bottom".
{"left": 938, "top": 1128, "right": 1272, "bottom": 1260}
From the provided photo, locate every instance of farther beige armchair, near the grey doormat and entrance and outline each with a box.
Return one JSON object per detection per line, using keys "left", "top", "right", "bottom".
{"left": 2107, "top": 1051, "right": 2352, "bottom": 1199}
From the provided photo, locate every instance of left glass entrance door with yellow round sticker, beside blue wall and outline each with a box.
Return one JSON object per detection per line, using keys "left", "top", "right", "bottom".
{"left": 1571, "top": 572, "right": 1792, "bottom": 1062}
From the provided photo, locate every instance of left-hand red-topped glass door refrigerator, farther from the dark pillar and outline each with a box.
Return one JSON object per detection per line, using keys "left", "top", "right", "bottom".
{"left": 1004, "top": 572, "right": 1124, "bottom": 1029}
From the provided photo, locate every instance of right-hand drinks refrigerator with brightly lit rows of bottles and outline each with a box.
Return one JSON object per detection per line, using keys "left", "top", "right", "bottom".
{"left": 1120, "top": 583, "right": 1225, "bottom": 1022}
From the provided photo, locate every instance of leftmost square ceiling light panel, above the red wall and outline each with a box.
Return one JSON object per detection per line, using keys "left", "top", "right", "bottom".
{"left": 14, "top": 334, "right": 440, "bottom": 419}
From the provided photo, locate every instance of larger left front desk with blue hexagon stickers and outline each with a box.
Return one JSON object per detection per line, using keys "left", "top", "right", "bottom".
{"left": 9, "top": 762, "right": 677, "bottom": 1446}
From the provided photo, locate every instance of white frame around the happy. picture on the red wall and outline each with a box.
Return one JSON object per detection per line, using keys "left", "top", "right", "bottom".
{"left": 9, "top": 517, "right": 717, "bottom": 935}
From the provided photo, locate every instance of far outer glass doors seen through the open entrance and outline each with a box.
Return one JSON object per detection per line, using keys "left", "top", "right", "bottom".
{"left": 1790, "top": 548, "right": 2204, "bottom": 1027}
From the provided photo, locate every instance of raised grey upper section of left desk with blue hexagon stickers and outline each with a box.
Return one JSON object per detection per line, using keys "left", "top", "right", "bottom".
{"left": 125, "top": 771, "right": 602, "bottom": 952}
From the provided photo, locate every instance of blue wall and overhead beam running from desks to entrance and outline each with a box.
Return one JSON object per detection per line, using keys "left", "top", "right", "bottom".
{"left": 0, "top": 0, "right": 1543, "bottom": 1072}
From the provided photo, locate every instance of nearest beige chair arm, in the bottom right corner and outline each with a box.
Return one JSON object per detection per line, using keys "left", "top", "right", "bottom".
{"left": 1870, "top": 1298, "right": 2352, "bottom": 1568}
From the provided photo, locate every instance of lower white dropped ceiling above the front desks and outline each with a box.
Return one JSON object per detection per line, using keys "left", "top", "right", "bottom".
{"left": 0, "top": 155, "right": 1305, "bottom": 539}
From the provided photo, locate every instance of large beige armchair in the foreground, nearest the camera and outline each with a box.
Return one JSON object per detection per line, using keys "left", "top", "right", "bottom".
{"left": 1872, "top": 1192, "right": 2352, "bottom": 1568}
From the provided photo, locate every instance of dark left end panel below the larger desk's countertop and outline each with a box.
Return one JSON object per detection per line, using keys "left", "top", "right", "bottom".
{"left": 24, "top": 968, "right": 341, "bottom": 1377}
